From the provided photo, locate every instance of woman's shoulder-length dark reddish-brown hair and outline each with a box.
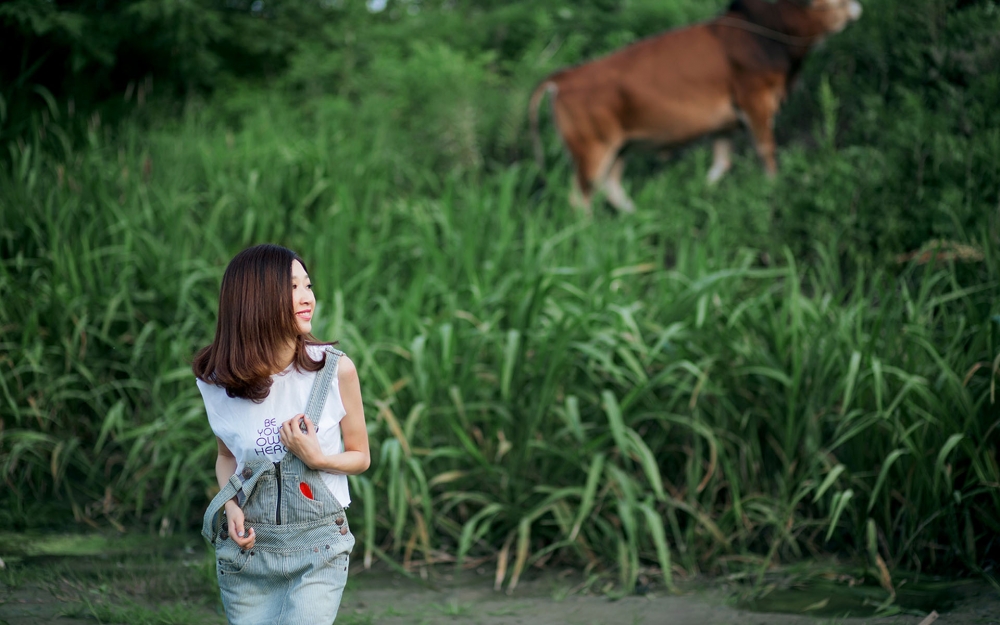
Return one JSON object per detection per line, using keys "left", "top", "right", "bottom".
{"left": 191, "top": 244, "right": 326, "bottom": 403}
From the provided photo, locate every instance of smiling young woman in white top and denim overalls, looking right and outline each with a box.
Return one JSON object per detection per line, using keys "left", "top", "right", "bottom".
{"left": 192, "top": 245, "right": 370, "bottom": 625}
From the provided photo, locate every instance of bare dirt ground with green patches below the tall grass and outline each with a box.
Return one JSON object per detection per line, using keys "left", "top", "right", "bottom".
{"left": 0, "top": 535, "right": 1000, "bottom": 625}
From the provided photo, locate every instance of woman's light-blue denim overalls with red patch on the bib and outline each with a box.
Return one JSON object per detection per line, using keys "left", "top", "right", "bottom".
{"left": 202, "top": 347, "right": 354, "bottom": 625}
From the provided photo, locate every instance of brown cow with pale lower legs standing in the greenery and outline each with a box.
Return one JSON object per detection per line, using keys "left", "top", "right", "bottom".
{"left": 529, "top": 0, "right": 861, "bottom": 213}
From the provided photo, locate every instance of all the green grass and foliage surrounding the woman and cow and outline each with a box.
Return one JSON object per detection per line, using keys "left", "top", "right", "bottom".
{"left": 0, "top": 0, "right": 1000, "bottom": 608}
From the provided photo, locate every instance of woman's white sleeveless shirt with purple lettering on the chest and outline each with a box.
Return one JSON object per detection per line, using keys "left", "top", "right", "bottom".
{"left": 197, "top": 345, "right": 351, "bottom": 508}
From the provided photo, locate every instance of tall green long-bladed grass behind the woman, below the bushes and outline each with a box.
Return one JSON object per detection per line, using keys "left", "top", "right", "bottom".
{"left": 0, "top": 89, "right": 1000, "bottom": 589}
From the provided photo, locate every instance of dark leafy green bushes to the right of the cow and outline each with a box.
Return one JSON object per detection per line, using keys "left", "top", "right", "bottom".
{"left": 778, "top": 0, "right": 1000, "bottom": 252}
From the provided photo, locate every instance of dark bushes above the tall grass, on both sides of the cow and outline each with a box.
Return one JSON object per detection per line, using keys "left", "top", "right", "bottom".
{"left": 0, "top": 0, "right": 1000, "bottom": 256}
